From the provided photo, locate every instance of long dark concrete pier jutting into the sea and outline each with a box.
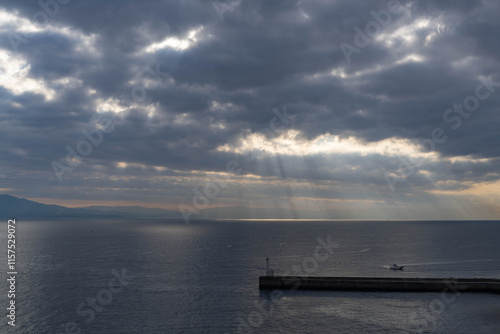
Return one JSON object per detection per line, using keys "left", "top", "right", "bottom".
{"left": 259, "top": 276, "right": 500, "bottom": 293}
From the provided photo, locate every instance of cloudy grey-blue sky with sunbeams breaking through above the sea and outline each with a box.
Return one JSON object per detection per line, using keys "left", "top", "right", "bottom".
{"left": 0, "top": 0, "right": 500, "bottom": 219}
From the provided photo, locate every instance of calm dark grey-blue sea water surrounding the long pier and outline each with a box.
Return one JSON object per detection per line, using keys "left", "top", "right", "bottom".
{"left": 0, "top": 220, "right": 500, "bottom": 333}
